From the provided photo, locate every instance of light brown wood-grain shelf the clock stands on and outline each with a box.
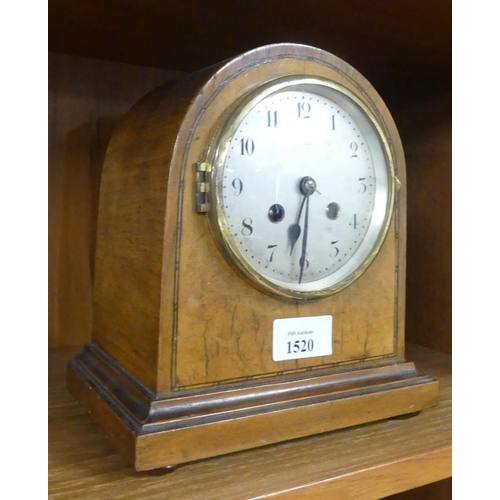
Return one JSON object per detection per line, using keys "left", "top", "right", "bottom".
{"left": 49, "top": 346, "right": 452, "bottom": 500}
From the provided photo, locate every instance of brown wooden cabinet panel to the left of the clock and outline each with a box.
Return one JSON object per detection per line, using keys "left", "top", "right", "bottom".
{"left": 48, "top": 54, "right": 182, "bottom": 346}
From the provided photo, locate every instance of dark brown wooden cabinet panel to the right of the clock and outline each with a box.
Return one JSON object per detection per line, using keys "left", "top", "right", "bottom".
{"left": 395, "top": 93, "right": 452, "bottom": 354}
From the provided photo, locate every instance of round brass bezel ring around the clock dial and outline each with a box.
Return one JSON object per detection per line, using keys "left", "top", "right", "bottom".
{"left": 207, "top": 75, "right": 398, "bottom": 300}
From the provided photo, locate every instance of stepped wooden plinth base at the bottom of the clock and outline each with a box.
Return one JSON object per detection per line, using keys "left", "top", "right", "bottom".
{"left": 68, "top": 344, "right": 438, "bottom": 470}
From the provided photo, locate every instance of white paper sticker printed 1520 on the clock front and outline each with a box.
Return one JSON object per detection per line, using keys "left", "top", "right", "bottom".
{"left": 273, "top": 316, "right": 333, "bottom": 361}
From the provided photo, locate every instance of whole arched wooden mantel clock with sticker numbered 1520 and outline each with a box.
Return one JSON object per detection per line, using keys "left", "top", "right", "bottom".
{"left": 68, "top": 44, "right": 437, "bottom": 470}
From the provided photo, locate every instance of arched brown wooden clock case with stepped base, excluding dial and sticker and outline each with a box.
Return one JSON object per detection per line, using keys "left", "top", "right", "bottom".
{"left": 68, "top": 44, "right": 438, "bottom": 470}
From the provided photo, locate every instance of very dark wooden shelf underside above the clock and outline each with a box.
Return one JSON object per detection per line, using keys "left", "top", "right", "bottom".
{"left": 48, "top": 0, "right": 452, "bottom": 98}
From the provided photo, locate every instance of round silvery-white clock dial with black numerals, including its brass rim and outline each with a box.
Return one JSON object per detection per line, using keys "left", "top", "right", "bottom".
{"left": 207, "top": 78, "right": 394, "bottom": 298}
